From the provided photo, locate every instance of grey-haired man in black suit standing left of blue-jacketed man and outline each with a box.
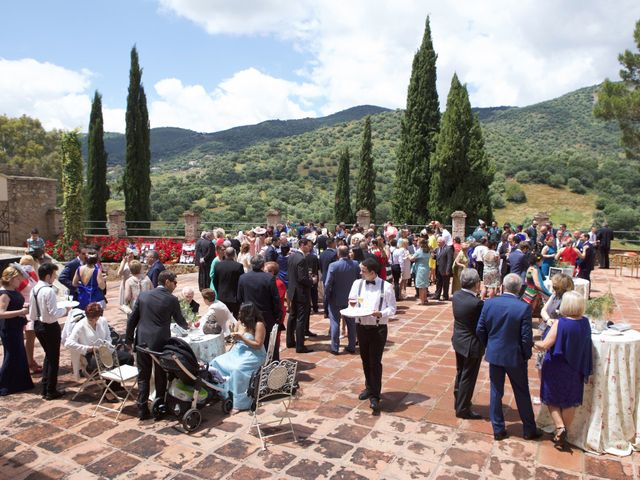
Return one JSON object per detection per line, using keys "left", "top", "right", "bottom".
{"left": 451, "top": 268, "right": 484, "bottom": 420}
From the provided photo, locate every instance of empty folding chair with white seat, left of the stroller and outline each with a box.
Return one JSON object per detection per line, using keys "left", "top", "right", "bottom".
{"left": 92, "top": 345, "right": 138, "bottom": 422}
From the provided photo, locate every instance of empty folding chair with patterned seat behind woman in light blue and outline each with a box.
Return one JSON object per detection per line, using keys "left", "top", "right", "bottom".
{"left": 249, "top": 359, "right": 298, "bottom": 450}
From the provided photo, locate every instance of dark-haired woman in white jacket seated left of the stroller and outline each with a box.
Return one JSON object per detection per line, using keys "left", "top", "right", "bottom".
{"left": 65, "top": 302, "right": 133, "bottom": 372}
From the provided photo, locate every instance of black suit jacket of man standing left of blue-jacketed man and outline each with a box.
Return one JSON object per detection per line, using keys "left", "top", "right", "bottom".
{"left": 451, "top": 290, "right": 484, "bottom": 358}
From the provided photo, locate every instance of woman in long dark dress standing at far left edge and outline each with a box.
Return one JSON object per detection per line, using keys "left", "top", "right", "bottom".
{"left": 0, "top": 267, "right": 33, "bottom": 396}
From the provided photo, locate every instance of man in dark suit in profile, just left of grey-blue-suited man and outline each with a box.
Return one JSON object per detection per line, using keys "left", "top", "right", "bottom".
{"left": 287, "top": 237, "right": 313, "bottom": 353}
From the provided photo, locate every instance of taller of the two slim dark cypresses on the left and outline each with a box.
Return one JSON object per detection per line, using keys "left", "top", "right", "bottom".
{"left": 122, "top": 46, "right": 151, "bottom": 235}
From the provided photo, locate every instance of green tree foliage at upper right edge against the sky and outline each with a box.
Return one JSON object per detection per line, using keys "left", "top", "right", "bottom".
{"left": 593, "top": 20, "right": 640, "bottom": 160}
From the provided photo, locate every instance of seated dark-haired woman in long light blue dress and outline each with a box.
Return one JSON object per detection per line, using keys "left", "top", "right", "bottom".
{"left": 209, "top": 303, "right": 267, "bottom": 410}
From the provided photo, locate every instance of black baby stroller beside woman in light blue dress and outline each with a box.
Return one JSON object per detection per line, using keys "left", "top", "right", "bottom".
{"left": 137, "top": 337, "right": 233, "bottom": 432}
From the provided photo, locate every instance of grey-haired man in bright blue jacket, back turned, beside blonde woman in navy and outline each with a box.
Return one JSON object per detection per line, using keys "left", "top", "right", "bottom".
{"left": 476, "top": 273, "right": 542, "bottom": 440}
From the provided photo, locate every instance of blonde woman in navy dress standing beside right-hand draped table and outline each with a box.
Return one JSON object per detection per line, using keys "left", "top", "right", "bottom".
{"left": 534, "top": 291, "right": 593, "bottom": 447}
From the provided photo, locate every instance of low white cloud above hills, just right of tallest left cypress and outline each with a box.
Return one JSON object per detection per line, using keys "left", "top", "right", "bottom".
{"left": 149, "top": 68, "right": 317, "bottom": 132}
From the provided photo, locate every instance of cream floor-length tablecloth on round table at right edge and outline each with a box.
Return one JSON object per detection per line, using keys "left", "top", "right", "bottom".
{"left": 537, "top": 330, "right": 640, "bottom": 456}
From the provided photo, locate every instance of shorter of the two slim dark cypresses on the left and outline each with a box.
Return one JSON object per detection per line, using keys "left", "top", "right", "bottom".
{"left": 87, "top": 90, "right": 109, "bottom": 234}
